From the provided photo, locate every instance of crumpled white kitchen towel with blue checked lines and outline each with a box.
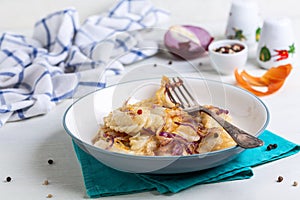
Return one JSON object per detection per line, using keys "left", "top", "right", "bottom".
{"left": 0, "top": 0, "right": 168, "bottom": 127}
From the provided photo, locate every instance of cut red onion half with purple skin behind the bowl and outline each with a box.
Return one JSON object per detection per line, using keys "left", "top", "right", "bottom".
{"left": 164, "top": 25, "right": 214, "bottom": 59}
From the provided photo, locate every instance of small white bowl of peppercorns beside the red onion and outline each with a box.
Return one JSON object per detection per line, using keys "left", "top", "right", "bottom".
{"left": 208, "top": 40, "right": 248, "bottom": 75}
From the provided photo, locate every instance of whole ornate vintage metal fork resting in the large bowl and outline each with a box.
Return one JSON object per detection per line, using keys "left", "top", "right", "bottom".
{"left": 166, "top": 77, "right": 264, "bottom": 149}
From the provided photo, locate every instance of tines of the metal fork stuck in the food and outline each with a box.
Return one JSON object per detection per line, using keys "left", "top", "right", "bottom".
{"left": 167, "top": 77, "right": 198, "bottom": 109}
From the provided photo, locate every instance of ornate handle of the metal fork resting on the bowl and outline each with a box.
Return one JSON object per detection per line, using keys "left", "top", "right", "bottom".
{"left": 199, "top": 106, "right": 264, "bottom": 149}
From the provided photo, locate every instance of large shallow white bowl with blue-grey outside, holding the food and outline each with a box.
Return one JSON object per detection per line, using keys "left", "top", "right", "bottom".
{"left": 63, "top": 78, "right": 269, "bottom": 174}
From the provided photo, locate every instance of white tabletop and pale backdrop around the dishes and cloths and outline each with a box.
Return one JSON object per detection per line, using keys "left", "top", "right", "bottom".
{"left": 0, "top": 0, "right": 300, "bottom": 200}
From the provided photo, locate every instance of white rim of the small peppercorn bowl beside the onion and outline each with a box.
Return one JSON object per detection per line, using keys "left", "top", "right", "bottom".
{"left": 208, "top": 39, "right": 248, "bottom": 57}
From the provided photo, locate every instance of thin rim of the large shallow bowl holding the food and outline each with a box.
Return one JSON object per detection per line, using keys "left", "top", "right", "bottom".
{"left": 62, "top": 76, "right": 270, "bottom": 160}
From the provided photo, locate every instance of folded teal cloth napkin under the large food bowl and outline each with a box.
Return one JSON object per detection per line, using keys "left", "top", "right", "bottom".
{"left": 73, "top": 130, "right": 300, "bottom": 198}
